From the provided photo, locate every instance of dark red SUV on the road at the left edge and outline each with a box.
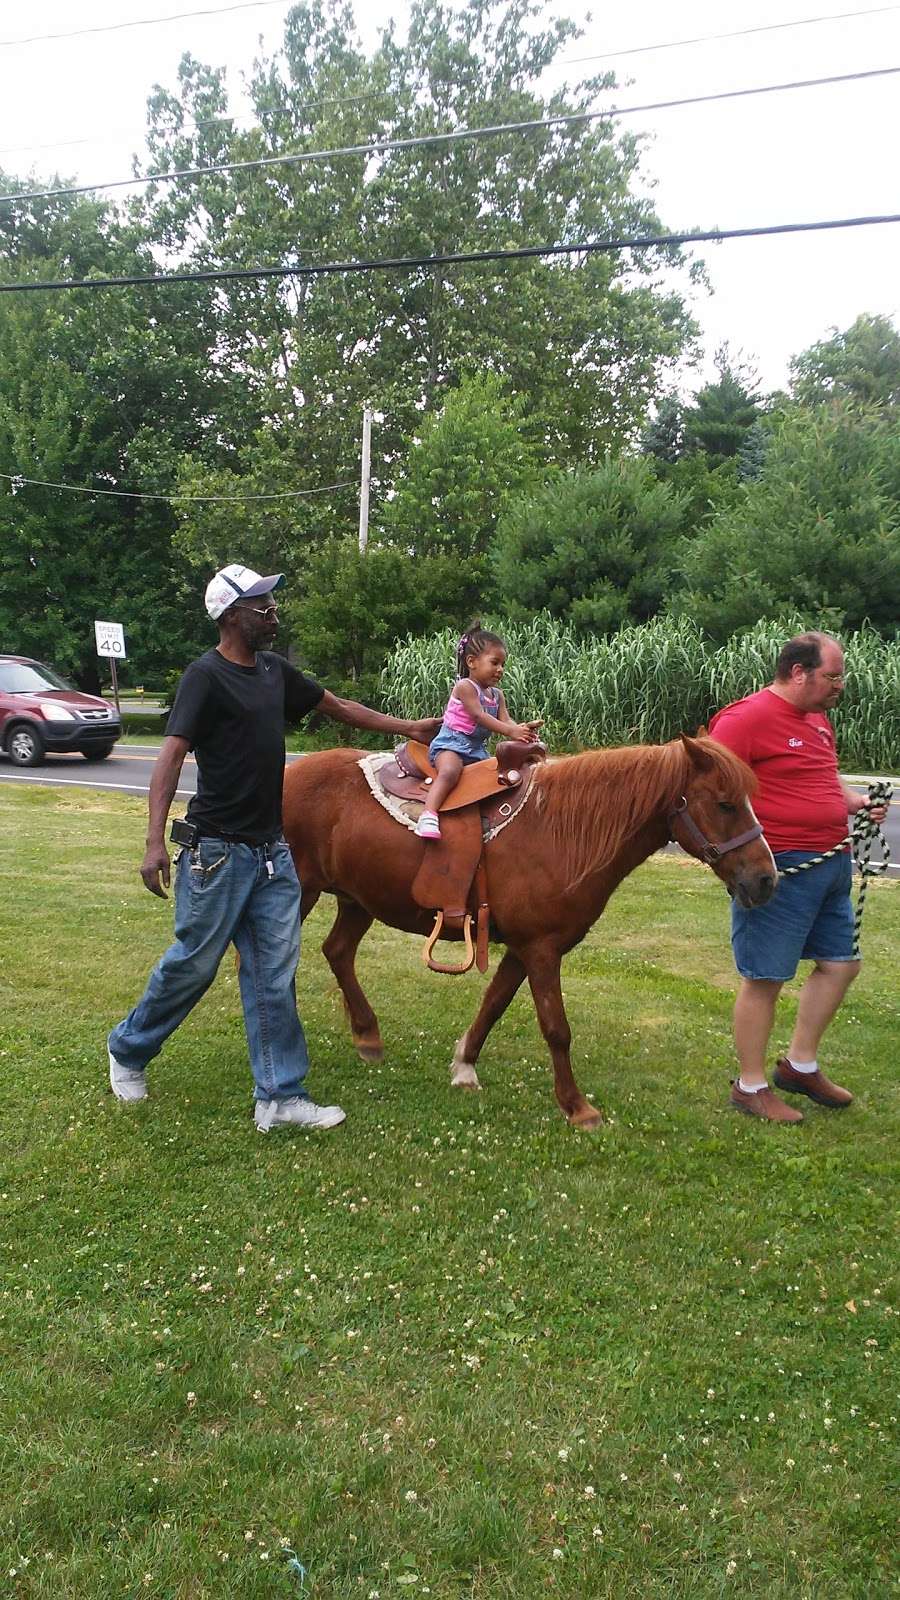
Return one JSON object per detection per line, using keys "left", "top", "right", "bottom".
{"left": 0, "top": 656, "right": 122, "bottom": 766}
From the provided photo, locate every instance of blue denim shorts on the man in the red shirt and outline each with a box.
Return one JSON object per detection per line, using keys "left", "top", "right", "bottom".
{"left": 732, "top": 850, "right": 855, "bottom": 982}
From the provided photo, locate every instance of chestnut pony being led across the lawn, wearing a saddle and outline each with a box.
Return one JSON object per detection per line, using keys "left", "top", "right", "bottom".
{"left": 283, "top": 734, "right": 777, "bottom": 1128}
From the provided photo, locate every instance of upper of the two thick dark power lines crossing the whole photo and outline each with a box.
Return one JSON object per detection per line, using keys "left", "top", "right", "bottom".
{"left": 0, "top": 67, "right": 900, "bottom": 205}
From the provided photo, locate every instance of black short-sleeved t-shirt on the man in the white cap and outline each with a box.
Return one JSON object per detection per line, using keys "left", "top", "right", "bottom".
{"left": 165, "top": 650, "right": 325, "bottom": 845}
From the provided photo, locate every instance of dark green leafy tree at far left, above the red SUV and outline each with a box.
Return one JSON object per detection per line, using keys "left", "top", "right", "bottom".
{"left": 0, "top": 178, "right": 215, "bottom": 688}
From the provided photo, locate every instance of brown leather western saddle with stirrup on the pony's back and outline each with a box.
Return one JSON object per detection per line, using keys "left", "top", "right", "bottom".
{"left": 369, "top": 739, "right": 546, "bottom": 973}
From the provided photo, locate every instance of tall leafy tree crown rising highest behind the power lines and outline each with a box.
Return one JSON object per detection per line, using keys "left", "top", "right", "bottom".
{"left": 138, "top": 0, "right": 693, "bottom": 494}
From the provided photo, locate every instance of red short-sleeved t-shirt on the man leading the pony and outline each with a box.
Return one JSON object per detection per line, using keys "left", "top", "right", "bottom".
{"left": 709, "top": 690, "right": 847, "bottom": 851}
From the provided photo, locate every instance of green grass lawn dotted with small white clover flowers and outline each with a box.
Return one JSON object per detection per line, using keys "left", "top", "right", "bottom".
{"left": 0, "top": 786, "right": 900, "bottom": 1600}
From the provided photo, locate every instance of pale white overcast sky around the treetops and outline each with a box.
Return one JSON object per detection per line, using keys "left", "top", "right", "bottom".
{"left": 0, "top": 0, "right": 900, "bottom": 389}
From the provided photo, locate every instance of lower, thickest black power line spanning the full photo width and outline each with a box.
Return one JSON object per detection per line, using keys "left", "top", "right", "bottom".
{"left": 0, "top": 211, "right": 900, "bottom": 294}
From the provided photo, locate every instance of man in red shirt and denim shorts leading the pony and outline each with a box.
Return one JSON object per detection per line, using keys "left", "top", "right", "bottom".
{"left": 709, "top": 634, "right": 886, "bottom": 1122}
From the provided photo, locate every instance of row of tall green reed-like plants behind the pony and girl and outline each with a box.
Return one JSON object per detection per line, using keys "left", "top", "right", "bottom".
{"left": 381, "top": 614, "right": 900, "bottom": 773}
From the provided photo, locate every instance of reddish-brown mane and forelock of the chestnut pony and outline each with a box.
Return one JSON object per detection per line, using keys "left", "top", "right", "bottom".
{"left": 535, "top": 738, "right": 756, "bottom": 888}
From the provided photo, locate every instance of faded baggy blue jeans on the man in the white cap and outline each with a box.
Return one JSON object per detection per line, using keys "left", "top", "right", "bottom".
{"left": 109, "top": 838, "right": 309, "bottom": 1101}
